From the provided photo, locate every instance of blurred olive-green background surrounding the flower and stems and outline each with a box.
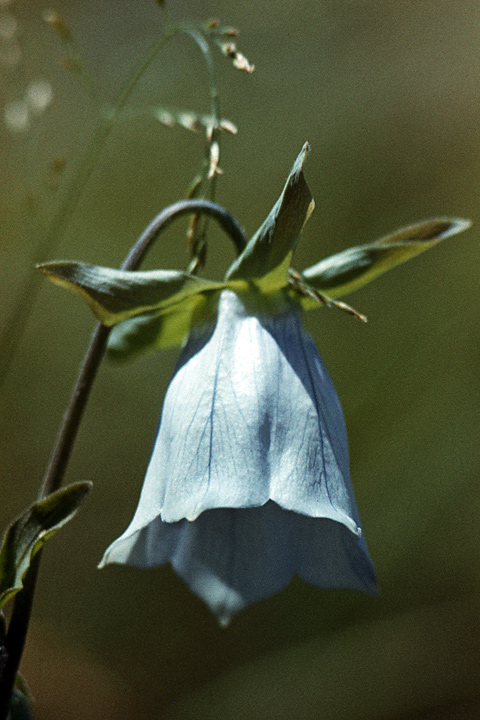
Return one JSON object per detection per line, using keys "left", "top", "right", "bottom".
{"left": 0, "top": 0, "right": 480, "bottom": 720}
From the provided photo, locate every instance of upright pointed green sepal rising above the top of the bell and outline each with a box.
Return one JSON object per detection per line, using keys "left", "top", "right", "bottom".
{"left": 225, "top": 143, "right": 314, "bottom": 291}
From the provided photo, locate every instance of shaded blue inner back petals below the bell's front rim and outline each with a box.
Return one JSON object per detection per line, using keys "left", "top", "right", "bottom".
{"left": 101, "top": 502, "right": 377, "bottom": 624}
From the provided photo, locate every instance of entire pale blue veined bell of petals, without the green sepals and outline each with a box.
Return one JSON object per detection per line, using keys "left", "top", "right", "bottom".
{"left": 101, "top": 290, "right": 376, "bottom": 622}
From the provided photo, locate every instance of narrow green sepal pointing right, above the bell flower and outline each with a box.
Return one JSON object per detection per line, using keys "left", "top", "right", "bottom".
{"left": 301, "top": 218, "right": 471, "bottom": 309}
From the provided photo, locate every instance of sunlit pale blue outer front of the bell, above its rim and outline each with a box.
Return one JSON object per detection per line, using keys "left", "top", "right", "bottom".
{"left": 105, "top": 290, "right": 361, "bottom": 535}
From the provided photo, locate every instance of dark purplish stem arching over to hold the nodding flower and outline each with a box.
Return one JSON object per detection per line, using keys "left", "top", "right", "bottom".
{"left": 0, "top": 200, "right": 246, "bottom": 720}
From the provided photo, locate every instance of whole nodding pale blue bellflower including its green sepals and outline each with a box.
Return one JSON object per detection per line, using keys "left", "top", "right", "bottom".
{"left": 39, "top": 146, "right": 466, "bottom": 623}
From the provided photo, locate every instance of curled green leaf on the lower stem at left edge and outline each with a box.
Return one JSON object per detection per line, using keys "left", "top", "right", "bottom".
{"left": 0, "top": 482, "right": 92, "bottom": 608}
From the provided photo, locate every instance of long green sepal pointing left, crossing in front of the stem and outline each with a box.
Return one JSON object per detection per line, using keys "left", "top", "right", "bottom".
{"left": 38, "top": 261, "right": 224, "bottom": 327}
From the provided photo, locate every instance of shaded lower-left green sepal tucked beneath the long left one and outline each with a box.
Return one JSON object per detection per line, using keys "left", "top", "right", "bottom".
{"left": 107, "top": 291, "right": 219, "bottom": 361}
